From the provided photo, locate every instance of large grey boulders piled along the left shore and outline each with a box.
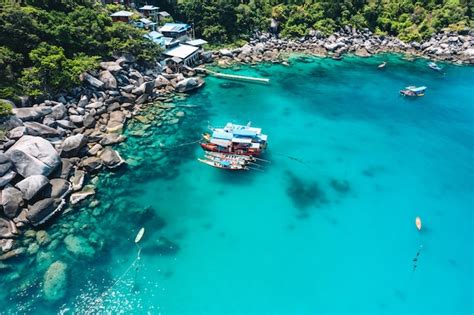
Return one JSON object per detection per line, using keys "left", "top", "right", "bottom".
{"left": 0, "top": 56, "right": 204, "bottom": 260}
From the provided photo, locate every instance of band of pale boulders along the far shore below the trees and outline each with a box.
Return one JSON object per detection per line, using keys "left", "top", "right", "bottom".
{"left": 213, "top": 26, "right": 474, "bottom": 66}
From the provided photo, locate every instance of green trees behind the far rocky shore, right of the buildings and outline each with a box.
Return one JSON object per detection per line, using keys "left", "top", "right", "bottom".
{"left": 176, "top": 0, "right": 474, "bottom": 42}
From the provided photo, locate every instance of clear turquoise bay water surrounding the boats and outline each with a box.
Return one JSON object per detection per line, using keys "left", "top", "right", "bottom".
{"left": 1, "top": 56, "right": 474, "bottom": 314}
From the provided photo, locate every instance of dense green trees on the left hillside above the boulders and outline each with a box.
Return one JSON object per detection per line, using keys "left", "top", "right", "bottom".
{"left": 0, "top": 0, "right": 160, "bottom": 98}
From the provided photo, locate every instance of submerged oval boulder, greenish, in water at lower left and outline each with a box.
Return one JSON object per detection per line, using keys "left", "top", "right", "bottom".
{"left": 43, "top": 260, "right": 67, "bottom": 301}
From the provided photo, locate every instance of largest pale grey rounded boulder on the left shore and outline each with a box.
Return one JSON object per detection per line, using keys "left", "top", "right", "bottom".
{"left": 5, "top": 136, "right": 61, "bottom": 178}
